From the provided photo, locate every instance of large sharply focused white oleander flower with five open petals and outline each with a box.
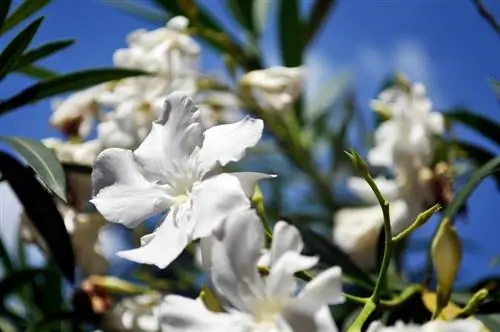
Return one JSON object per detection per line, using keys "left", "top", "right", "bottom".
{"left": 91, "top": 93, "right": 270, "bottom": 268}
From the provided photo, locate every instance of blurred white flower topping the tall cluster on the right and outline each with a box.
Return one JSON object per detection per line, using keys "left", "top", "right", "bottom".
{"left": 368, "top": 83, "right": 444, "bottom": 168}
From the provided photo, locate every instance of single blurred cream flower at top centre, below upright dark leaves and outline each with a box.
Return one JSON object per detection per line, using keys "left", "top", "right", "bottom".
{"left": 241, "top": 67, "right": 303, "bottom": 111}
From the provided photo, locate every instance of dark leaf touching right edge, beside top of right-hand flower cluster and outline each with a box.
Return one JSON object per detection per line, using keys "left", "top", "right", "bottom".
{"left": 443, "top": 108, "right": 500, "bottom": 144}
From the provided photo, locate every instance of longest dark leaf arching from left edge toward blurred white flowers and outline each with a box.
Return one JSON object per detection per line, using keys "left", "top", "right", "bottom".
{"left": 0, "top": 68, "right": 147, "bottom": 114}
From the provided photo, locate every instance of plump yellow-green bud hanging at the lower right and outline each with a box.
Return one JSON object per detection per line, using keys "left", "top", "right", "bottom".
{"left": 431, "top": 218, "right": 462, "bottom": 314}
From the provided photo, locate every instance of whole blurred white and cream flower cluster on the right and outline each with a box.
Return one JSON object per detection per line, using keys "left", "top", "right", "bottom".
{"left": 333, "top": 83, "right": 444, "bottom": 269}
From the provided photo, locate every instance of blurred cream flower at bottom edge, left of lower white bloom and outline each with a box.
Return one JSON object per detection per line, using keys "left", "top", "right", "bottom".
{"left": 100, "top": 293, "right": 162, "bottom": 332}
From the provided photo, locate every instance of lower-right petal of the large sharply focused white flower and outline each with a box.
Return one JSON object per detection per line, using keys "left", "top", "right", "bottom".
{"left": 191, "top": 173, "right": 250, "bottom": 239}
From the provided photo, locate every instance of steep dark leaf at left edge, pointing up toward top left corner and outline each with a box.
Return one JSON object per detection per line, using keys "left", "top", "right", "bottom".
{"left": 0, "top": 17, "right": 43, "bottom": 80}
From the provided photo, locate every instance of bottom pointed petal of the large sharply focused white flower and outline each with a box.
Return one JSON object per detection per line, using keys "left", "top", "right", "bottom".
{"left": 117, "top": 213, "right": 190, "bottom": 269}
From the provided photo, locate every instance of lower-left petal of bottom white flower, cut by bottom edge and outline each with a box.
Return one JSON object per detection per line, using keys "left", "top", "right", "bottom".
{"left": 160, "top": 295, "right": 247, "bottom": 332}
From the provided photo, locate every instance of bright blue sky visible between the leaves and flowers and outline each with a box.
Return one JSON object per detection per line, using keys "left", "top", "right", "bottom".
{"left": 0, "top": 0, "right": 500, "bottom": 281}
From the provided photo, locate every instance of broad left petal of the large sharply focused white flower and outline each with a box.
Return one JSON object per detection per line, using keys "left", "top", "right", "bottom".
{"left": 91, "top": 148, "right": 169, "bottom": 227}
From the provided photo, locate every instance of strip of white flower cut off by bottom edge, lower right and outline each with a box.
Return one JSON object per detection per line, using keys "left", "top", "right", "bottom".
{"left": 367, "top": 319, "right": 484, "bottom": 332}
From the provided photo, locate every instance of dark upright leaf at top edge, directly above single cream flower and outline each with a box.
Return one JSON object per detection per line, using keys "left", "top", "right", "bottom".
{"left": 278, "top": 0, "right": 304, "bottom": 67}
